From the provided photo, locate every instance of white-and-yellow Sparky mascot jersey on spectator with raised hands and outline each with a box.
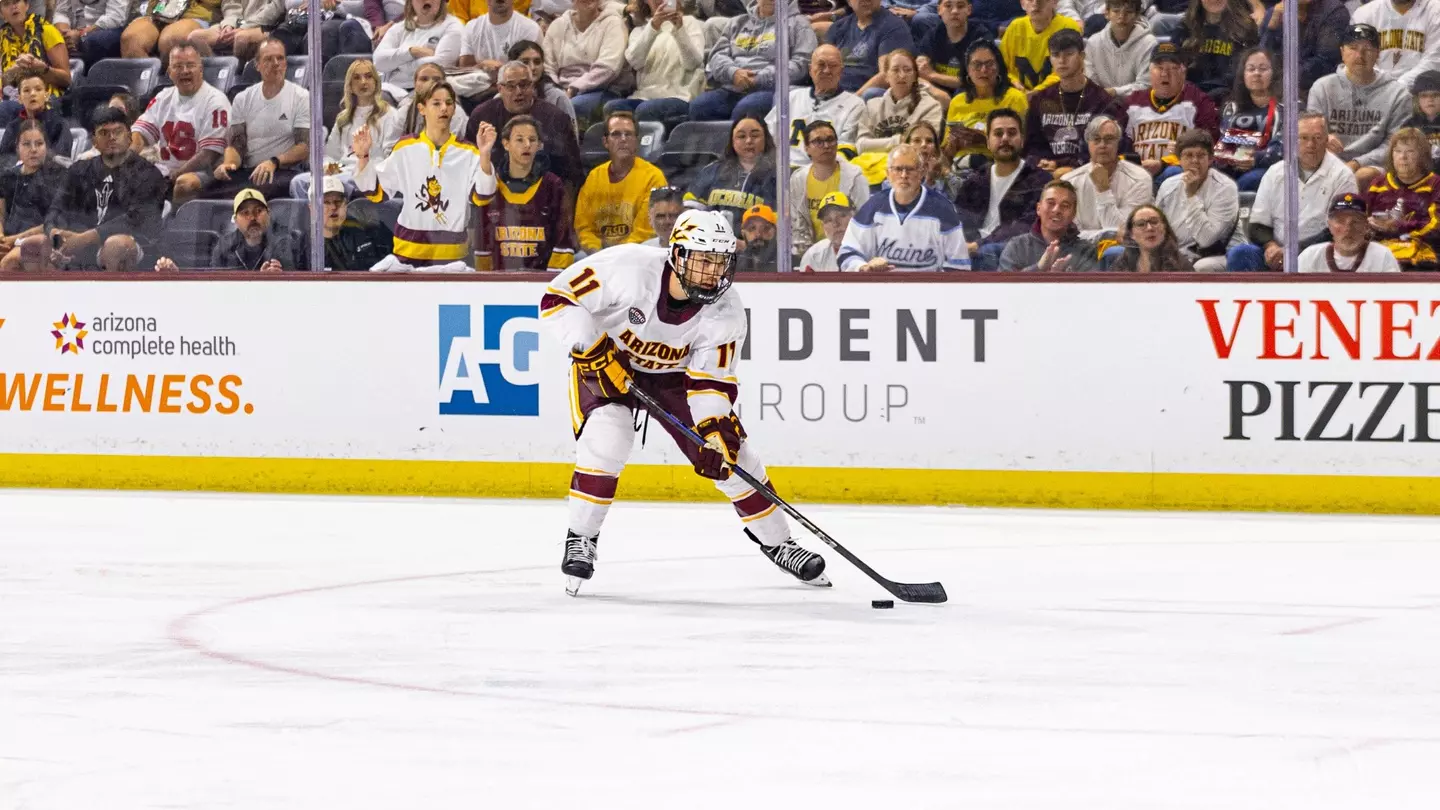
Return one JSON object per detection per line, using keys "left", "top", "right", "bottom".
{"left": 356, "top": 133, "right": 495, "bottom": 267}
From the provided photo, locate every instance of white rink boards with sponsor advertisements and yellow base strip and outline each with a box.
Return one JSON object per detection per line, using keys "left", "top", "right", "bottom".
{"left": 0, "top": 280, "right": 1440, "bottom": 510}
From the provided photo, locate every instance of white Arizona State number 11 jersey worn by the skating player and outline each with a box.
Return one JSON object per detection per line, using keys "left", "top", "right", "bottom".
{"left": 540, "top": 244, "right": 746, "bottom": 431}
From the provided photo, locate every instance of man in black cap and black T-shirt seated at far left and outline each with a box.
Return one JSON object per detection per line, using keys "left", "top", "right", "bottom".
{"left": 46, "top": 105, "right": 166, "bottom": 270}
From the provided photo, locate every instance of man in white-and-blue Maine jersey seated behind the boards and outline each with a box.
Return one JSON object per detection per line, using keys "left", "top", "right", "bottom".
{"left": 840, "top": 144, "right": 971, "bottom": 272}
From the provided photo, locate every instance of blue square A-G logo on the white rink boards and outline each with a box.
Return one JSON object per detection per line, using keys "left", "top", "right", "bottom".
{"left": 439, "top": 304, "right": 540, "bottom": 417}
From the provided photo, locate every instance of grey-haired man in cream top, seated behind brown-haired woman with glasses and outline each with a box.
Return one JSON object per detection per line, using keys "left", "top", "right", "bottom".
{"left": 1066, "top": 115, "right": 1152, "bottom": 239}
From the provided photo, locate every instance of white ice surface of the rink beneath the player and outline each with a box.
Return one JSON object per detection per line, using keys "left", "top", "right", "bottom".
{"left": 0, "top": 493, "right": 1440, "bottom": 810}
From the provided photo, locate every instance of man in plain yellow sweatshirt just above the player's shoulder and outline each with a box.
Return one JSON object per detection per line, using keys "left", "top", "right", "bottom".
{"left": 575, "top": 111, "right": 667, "bottom": 254}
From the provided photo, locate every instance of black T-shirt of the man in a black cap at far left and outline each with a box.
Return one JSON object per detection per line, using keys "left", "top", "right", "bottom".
{"left": 49, "top": 151, "right": 168, "bottom": 245}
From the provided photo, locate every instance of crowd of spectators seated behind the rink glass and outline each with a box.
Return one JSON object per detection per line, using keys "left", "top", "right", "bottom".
{"left": 0, "top": 0, "right": 1440, "bottom": 272}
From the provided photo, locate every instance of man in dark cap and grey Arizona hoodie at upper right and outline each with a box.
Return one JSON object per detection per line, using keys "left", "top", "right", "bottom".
{"left": 1306, "top": 23, "right": 1411, "bottom": 189}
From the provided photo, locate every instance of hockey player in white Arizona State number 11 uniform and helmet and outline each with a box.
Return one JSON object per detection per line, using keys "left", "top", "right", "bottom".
{"left": 540, "top": 210, "right": 829, "bottom": 595}
